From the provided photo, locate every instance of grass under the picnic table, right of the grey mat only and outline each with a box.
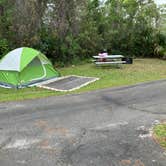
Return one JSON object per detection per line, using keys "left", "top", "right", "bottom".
{"left": 60, "top": 59, "right": 166, "bottom": 92}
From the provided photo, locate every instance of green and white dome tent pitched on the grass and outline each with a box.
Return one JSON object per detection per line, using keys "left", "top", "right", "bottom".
{"left": 0, "top": 47, "right": 59, "bottom": 88}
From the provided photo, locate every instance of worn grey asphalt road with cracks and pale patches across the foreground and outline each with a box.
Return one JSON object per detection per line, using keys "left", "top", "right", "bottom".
{"left": 0, "top": 80, "right": 166, "bottom": 166}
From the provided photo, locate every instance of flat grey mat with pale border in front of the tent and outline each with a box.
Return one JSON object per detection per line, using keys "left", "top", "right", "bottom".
{"left": 38, "top": 75, "right": 98, "bottom": 91}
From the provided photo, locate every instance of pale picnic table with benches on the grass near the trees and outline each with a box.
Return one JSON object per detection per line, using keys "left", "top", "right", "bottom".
{"left": 93, "top": 55, "right": 126, "bottom": 65}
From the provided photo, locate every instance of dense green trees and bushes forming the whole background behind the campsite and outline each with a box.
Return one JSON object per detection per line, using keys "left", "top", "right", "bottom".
{"left": 0, "top": 0, "right": 166, "bottom": 65}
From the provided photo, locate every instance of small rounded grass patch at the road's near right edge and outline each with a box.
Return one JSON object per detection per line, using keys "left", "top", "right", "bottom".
{"left": 154, "top": 123, "right": 166, "bottom": 148}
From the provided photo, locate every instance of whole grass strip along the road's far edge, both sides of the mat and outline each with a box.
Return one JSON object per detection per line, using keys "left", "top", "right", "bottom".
{"left": 0, "top": 59, "right": 166, "bottom": 102}
